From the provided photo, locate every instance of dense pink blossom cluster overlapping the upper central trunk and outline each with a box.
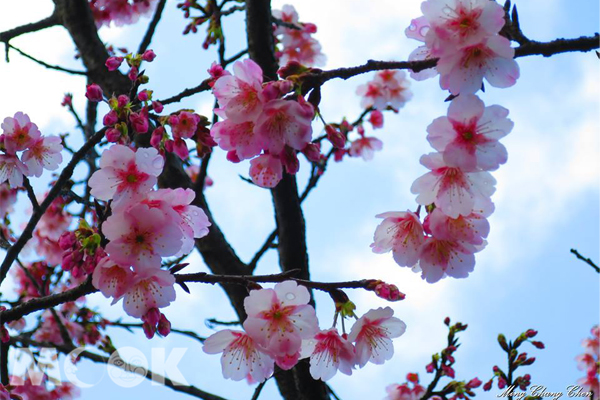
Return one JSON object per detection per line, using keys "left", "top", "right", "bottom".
{"left": 210, "top": 59, "right": 315, "bottom": 188}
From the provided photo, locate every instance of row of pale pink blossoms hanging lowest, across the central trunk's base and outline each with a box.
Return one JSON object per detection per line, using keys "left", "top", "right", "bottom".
{"left": 203, "top": 281, "right": 406, "bottom": 382}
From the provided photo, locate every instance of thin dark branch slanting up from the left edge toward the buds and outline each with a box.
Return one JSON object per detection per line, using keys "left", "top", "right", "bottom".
{"left": 0, "top": 129, "right": 106, "bottom": 284}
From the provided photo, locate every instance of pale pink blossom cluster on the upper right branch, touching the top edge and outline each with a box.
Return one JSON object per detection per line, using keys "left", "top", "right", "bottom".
{"left": 406, "top": 0, "right": 519, "bottom": 95}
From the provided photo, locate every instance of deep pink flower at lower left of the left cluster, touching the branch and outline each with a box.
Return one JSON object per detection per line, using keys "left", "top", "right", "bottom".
{"left": 92, "top": 257, "right": 133, "bottom": 304}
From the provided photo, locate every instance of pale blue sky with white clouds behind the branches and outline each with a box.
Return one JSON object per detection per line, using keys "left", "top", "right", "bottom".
{"left": 0, "top": 0, "right": 600, "bottom": 400}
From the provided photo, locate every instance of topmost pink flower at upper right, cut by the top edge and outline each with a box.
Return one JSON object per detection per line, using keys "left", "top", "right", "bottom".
{"left": 421, "top": 0, "right": 504, "bottom": 54}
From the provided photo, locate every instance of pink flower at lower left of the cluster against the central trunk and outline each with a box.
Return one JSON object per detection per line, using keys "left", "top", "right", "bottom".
{"left": 210, "top": 119, "right": 266, "bottom": 160}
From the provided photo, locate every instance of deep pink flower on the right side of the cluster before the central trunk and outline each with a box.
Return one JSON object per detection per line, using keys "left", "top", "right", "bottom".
{"left": 255, "top": 99, "right": 314, "bottom": 154}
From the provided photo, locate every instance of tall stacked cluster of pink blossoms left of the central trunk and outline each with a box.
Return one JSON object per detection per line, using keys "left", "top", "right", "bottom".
{"left": 89, "top": 144, "right": 210, "bottom": 328}
